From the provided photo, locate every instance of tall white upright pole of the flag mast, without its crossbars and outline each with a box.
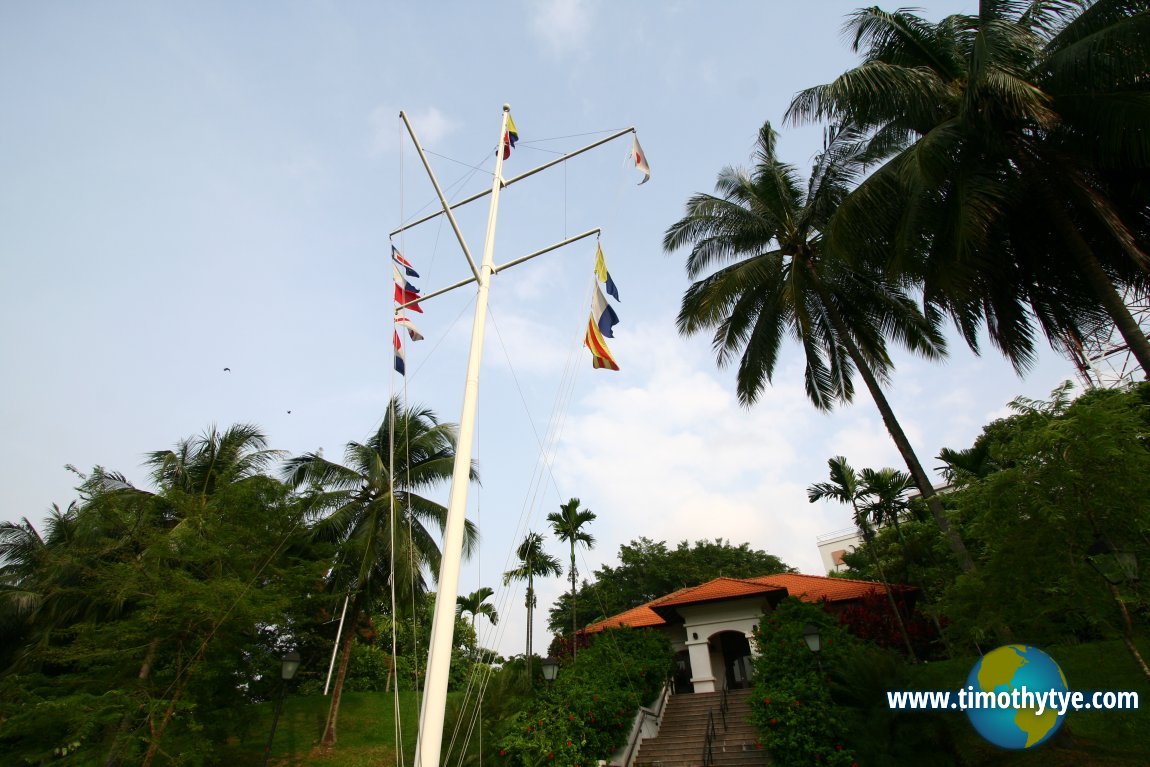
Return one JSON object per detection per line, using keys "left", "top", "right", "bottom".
{"left": 415, "top": 103, "right": 511, "bottom": 767}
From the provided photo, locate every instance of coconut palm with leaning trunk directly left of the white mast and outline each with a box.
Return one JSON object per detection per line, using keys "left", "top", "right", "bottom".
{"left": 282, "top": 398, "right": 478, "bottom": 747}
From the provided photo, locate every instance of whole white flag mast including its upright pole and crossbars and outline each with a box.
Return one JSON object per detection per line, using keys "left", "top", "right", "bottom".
{"left": 402, "top": 103, "right": 635, "bottom": 767}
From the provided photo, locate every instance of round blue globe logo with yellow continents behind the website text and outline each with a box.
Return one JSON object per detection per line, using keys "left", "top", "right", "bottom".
{"left": 966, "top": 644, "right": 1067, "bottom": 750}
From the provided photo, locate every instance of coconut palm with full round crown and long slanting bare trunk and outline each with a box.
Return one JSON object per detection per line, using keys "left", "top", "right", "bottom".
{"left": 664, "top": 123, "right": 973, "bottom": 570}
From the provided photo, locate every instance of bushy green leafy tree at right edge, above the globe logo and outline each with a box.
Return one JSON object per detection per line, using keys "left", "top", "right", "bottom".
{"left": 944, "top": 384, "right": 1150, "bottom": 676}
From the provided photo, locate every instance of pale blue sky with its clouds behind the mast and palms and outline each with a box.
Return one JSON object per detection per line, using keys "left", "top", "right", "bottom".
{"left": 0, "top": 0, "right": 1073, "bottom": 653}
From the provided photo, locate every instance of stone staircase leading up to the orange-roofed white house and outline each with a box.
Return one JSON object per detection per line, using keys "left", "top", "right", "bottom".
{"left": 635, "top": 690, "right": 769, "bottom": 767}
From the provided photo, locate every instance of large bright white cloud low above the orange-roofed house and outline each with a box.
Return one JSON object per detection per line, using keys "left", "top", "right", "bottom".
{"left": 555, "top": 322, "right": 826, "bottom": 572}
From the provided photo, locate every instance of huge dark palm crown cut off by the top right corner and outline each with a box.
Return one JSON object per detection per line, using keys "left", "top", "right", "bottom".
{"left": 787, "top": 0, "right": 1150, "bottom": 374}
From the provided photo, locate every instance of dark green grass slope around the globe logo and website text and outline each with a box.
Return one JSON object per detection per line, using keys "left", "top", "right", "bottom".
{"left": 911, "top": 641, "right": 1150, "bottom": 767}
